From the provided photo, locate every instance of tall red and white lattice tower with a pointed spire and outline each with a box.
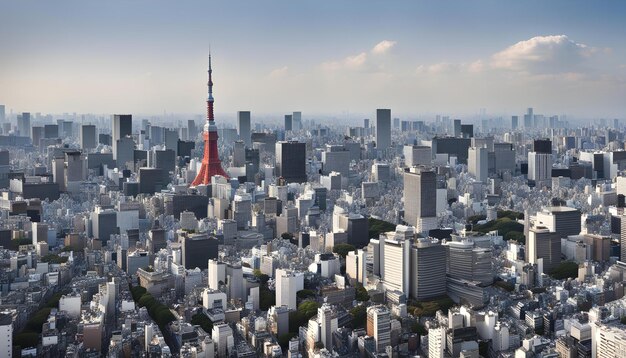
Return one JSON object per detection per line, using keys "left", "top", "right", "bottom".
{"left": 191, "top": 53, "right": 228, "bottom": 186}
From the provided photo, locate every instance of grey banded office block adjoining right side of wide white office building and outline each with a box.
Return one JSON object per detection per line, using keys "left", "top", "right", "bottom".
{"left": 410, "top": 238, "right": 446, "bottom": 300}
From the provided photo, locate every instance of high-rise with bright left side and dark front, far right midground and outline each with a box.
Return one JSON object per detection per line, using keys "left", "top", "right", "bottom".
{"left": 526, "top": 226, "right": 561, "bottom": 274}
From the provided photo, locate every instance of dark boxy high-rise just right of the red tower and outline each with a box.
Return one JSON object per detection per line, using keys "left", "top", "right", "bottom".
{"left": 276, "top": 141, "right": 306, "bottom": 183}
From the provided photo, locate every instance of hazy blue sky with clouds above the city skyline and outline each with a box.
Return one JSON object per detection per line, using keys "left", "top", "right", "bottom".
{"left": 0, "top": 0, "right": 626, "bottom": 118}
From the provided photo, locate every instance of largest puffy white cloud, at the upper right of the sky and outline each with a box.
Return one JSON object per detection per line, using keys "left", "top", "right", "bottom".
{"left": 491, "top": 35, "right": 594, "bottom": 74}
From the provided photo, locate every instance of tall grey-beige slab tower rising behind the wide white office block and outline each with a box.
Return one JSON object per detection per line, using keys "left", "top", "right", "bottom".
{"left": 403, "top": 167, "right": 437, "bottom": 232}
